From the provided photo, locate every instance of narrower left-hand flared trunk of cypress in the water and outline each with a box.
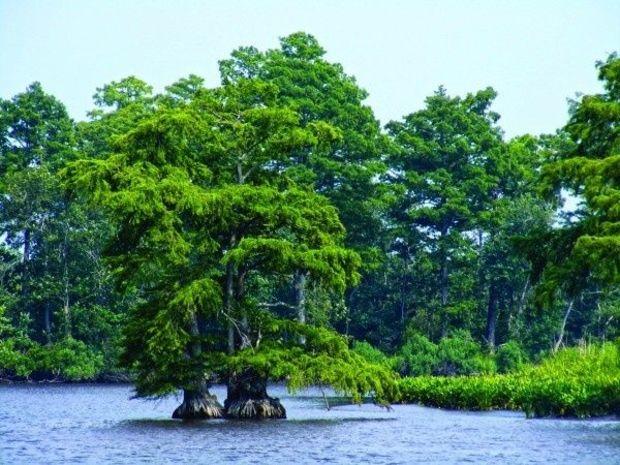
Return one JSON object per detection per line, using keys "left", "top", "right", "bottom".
{"left": 172, "top": 315, "right": 224, "bottom": 420}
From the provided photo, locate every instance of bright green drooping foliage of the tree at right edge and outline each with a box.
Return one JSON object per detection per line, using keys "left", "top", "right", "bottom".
{"left": 542, "top": 54, "right": 620, "bottom": 296}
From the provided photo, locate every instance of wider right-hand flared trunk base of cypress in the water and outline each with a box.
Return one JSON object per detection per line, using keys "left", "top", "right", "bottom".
{"left": 224, "top": 368, "right": 286, "bottom": 419}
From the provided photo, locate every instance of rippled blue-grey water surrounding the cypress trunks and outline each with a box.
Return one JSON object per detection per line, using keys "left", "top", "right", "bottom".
{"left": 0, "top": 385, "right": 620, "bottom": 465}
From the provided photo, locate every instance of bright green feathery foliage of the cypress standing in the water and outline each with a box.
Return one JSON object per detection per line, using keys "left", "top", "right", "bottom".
{"left": 63, "top": 60, "right": 368, "bottom": 396}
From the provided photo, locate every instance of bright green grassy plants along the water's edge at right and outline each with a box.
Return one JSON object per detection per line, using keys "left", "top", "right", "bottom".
{"left": 400, "top": 343, "right": 620, "bottom": 418}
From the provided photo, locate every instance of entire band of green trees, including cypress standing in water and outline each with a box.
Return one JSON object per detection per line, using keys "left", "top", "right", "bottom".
{"left": 0, "top": 33, "right": 620, "bottom": 418}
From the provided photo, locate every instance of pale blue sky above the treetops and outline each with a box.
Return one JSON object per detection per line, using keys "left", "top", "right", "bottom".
{"left": 0, "top": 0, "right": 620, "bottom": 136}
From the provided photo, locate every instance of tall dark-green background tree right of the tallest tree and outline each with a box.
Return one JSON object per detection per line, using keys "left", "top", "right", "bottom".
{"left": 388, "top": 88, "right": 503, "bottom": 335}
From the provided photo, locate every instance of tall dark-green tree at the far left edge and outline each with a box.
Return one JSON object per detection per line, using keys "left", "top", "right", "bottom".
{"left": 0, "top": 82, "right": 75, "bottom": 338}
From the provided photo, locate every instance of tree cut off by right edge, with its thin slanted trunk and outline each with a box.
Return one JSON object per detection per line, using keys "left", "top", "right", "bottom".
{"left": 531, "top": 54, "right": 620, "bottom": 349}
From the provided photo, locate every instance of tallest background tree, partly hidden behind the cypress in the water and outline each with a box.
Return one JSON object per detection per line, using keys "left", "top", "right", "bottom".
{"left": 220, "top": 32, "right": 388, "bottom": 338}
